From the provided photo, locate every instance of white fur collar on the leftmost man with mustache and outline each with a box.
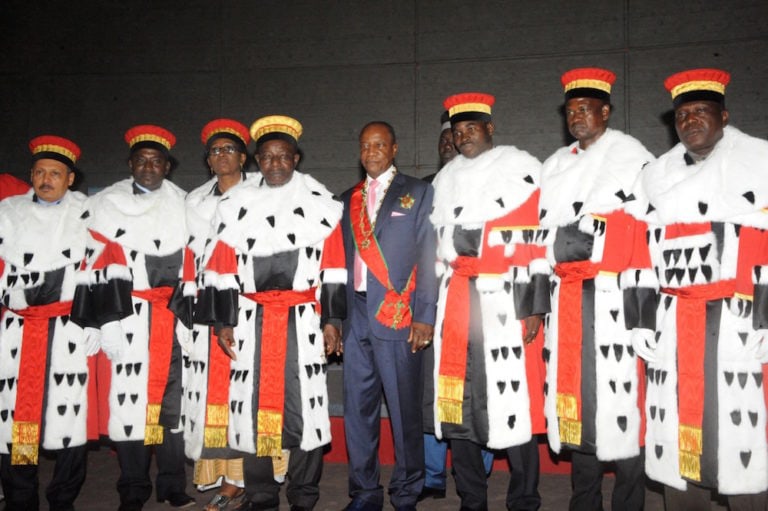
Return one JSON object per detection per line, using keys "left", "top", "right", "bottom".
{"left": 0, "top": 190, "right": 87, "bottom": 272}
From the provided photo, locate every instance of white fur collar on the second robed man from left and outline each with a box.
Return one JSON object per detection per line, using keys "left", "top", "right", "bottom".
{"left": 86, "top": 178, "right": 187, "bottom": 256}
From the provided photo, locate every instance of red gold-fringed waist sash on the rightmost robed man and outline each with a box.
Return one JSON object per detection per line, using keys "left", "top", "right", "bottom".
{"left": 661, "top": 279, "right": 736, "bottom": 481}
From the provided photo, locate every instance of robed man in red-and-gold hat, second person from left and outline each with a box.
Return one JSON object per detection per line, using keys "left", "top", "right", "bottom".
{"left": 72, "top": 125, "right": 195, "bottom": 511}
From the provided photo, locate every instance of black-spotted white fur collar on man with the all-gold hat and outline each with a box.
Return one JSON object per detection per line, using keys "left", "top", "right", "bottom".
{"left": 214, "top": 171, "right": 342, "bottom": 256}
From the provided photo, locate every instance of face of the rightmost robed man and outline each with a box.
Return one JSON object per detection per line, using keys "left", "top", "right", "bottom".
{"left": 675, "top": 101, "right": 728, "bottom": 157}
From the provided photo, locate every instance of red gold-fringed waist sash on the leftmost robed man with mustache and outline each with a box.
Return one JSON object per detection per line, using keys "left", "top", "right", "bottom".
{"left": 9, "top": 302, "right": 72, "bottom": 465}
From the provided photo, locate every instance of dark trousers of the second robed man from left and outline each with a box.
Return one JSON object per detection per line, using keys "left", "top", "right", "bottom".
{"left": 115, "top": 427, "right": 187, "bottom": 504}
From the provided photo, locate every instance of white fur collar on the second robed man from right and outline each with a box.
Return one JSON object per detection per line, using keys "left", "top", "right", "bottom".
{"left": 539, "top": 129, "right": 654, "bottom": 227}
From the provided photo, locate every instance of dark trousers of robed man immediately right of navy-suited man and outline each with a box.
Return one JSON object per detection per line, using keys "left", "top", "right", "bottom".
{"left": 451, "top": 436, "right": 541, "bottom": 511}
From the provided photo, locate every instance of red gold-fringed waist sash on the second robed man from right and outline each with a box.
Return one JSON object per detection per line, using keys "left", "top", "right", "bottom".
{"left": 555, "top": 260, "right": 599, "bottom": 445}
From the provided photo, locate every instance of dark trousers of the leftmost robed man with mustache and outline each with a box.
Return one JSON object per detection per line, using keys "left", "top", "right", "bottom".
{"left": 0, "top": 445, "right": 88, "bottom": 511}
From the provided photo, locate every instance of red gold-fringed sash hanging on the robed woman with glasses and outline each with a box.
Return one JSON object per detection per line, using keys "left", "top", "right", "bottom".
{"left": 204, "top": 328, "right": 230, "bottom": 447}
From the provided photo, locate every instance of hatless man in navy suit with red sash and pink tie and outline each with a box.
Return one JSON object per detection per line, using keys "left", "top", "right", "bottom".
{"left": 342, "top": 121, "right": 437, "bottom": 511}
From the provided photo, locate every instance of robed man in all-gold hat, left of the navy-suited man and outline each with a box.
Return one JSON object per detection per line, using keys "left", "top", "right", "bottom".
{"left": 195, "top": 115, "right": 346, "bottom": 511}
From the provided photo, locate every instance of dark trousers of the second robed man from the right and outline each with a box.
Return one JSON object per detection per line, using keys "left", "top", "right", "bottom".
{"left": 568, "top": 451, "right": 645, "bottom": 511}
